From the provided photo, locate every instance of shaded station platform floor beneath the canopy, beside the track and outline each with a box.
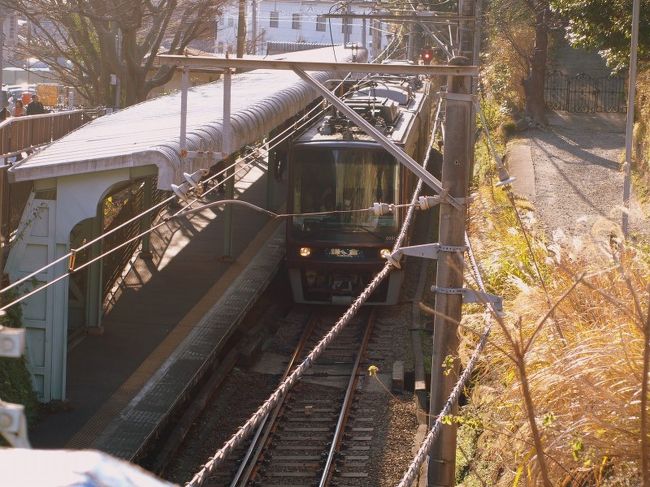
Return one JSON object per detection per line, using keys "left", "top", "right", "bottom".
{"left": 29, "top": 161, "right": 286, "bottom": 459}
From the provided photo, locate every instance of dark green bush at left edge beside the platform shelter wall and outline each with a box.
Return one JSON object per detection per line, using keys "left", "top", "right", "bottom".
{"left": 0, "top": 293, "right": 39, "bottom": 423}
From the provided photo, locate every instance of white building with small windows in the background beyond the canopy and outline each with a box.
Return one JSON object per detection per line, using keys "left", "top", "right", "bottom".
{"left": 214, "top": 0, "right": 386, "bottom": 55}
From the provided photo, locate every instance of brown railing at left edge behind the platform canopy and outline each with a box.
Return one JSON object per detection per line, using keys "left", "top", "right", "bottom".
{"left": 0, "top": 110, "right": 97, "bottom": 158}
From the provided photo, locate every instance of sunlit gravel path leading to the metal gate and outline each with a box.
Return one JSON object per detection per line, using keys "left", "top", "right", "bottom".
{"left": 527, "top": 112, "right": 650, "bottom": 244}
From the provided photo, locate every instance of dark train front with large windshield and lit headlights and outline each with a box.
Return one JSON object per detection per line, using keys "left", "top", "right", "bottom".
{"left": 287, "top": 141, "right": 402, "bottom": 304}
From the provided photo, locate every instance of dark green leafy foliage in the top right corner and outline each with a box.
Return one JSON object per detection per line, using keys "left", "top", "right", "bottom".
{"left": 551, "top": 0, "right": 650, "bottom": 70}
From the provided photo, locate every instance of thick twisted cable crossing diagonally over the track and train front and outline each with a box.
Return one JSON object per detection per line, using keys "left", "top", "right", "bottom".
{"left": 186, "top": 98, "right": 440, "bottom": 487}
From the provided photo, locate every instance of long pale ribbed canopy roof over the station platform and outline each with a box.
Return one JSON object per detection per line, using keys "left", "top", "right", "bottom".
{"left": 10, "top": 46, "right": 366, "bottom": 189}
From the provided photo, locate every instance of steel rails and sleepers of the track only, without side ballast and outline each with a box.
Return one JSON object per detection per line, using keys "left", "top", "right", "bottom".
{"left": 228, "top": 311, "right": 375, "bottom": 487}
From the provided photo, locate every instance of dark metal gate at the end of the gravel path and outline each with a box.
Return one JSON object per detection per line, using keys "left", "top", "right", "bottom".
{"left": 544, "top": 71, "right": 626, "bottom": 113}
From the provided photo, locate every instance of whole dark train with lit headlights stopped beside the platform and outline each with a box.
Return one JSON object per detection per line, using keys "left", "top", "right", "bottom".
{"left": 286, "top": 69, "right": 432, "bottom": 305}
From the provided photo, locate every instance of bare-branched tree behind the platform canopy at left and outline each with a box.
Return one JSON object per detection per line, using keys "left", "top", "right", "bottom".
{"left": 0, "top": 0, "right": 220, "bottom": 106}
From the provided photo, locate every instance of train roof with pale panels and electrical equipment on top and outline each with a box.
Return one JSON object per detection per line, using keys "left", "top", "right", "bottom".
{"left": 295, "top": 79, "right": 428, "bottom": 145}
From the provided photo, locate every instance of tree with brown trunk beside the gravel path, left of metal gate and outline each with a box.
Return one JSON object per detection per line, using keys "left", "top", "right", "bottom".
{"left": 487, "top": 0, "right": 552, "bottom": 125}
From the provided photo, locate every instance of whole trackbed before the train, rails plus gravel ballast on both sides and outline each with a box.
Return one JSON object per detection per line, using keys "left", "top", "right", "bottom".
{"left": 159, "top": 306, "right": 402, "bottom": 487}
